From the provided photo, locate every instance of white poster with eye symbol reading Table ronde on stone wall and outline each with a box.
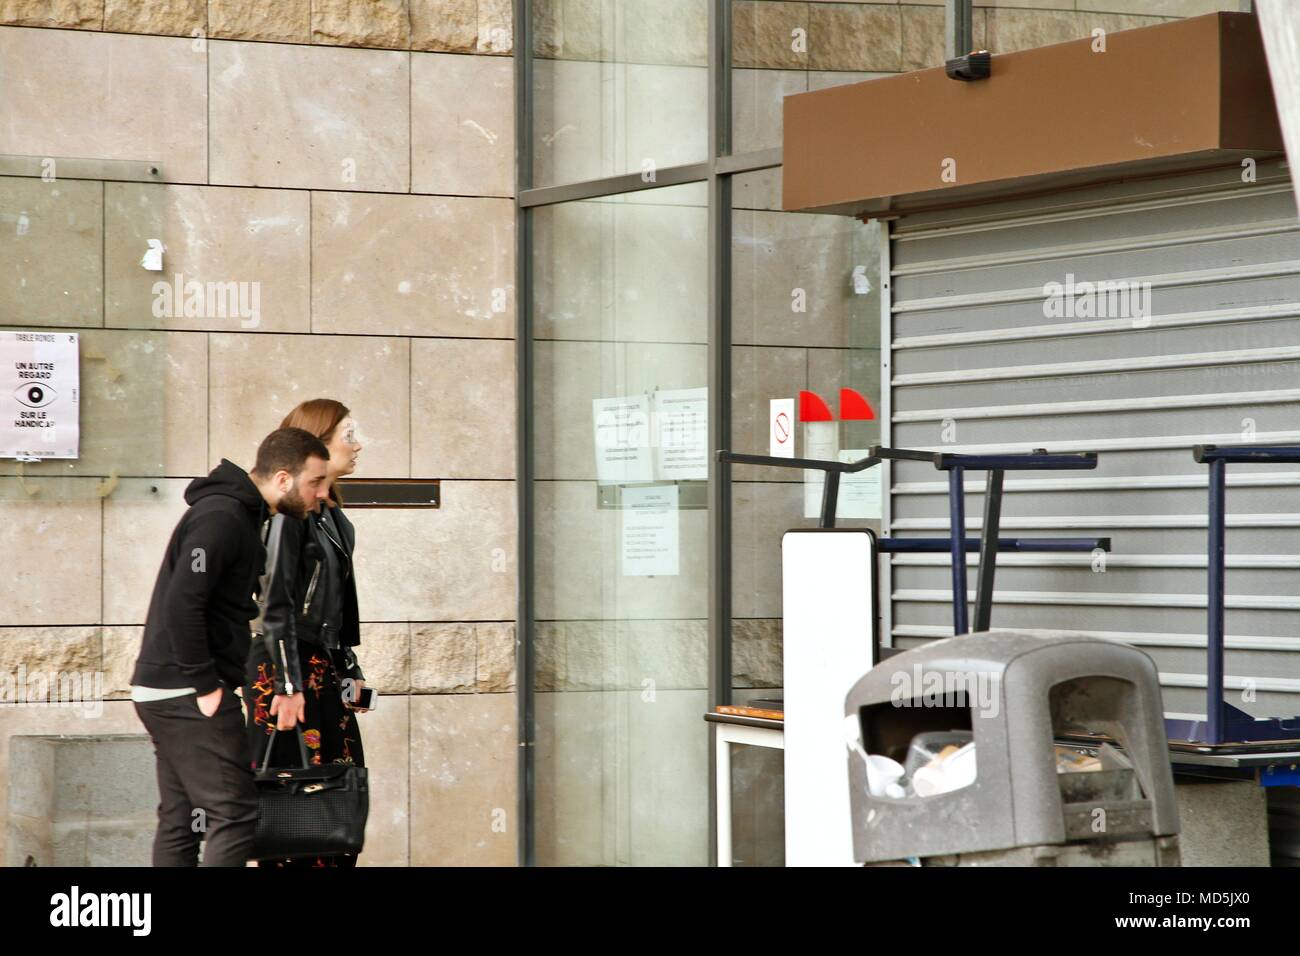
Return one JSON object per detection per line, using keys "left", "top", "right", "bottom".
{"left": 0, "top": 330, "right": 81, "bottom": 462}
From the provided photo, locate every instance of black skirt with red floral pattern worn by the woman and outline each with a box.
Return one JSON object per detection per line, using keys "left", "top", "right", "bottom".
{"left": 244, "top": 641, "right": 365, "bottom": 866}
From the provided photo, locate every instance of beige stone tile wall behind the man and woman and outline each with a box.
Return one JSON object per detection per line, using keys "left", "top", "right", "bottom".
{"left": 0, "top": 9, "right": 517, "bottom": 865}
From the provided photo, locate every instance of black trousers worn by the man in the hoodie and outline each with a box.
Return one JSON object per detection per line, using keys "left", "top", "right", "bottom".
{"left": 135, "top": 687, "right": 257, "bottom": 866}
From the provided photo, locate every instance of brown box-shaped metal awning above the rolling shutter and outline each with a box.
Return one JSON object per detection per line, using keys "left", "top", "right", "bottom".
{"left": 783, "top": 13, "right": 1283, "bottom": 216}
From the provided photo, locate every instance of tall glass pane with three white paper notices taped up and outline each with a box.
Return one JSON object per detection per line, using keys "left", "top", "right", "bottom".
{"left": 533, "top": 183, "right": 709, "bottom": 866}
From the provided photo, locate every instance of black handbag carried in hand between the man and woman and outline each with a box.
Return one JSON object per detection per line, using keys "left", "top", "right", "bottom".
{"left": 250, "top": 727, "right": 371, "bottom": 860}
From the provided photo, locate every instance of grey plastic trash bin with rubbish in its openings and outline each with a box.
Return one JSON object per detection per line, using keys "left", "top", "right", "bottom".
{"left": 845, "top": 631, "right": 1179, "bottom": 866}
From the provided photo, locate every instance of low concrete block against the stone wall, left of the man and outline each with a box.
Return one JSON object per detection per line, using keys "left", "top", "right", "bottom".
{"left": 5, "top": 734, "right": 159, "bottom": 866}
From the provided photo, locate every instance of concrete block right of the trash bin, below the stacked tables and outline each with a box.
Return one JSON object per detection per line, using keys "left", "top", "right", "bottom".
{"left": 1174, "top": 778, "right": 1269, "bottom": 866}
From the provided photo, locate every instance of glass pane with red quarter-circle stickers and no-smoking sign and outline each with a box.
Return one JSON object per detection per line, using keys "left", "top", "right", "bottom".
{"left": 731, "top": 169, "right": 880, "bottom": 865}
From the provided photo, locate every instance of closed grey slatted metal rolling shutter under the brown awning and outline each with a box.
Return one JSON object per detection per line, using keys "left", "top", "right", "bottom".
{"left": 881, "top": 163, "right": 1300, "bottom": 714}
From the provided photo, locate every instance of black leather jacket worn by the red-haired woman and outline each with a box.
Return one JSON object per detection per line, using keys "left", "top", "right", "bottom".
{"left": 254, "top": 507, "right": 365, "bottom": 695}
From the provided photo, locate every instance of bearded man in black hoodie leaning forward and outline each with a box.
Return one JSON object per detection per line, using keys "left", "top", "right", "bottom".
{"left": 131, "top": 428, "right": 329, "bottom": 866}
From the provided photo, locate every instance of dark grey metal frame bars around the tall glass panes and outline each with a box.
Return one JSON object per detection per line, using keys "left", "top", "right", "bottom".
{"left": 514, "top": 0, "right": 781, "bottom": 866}
